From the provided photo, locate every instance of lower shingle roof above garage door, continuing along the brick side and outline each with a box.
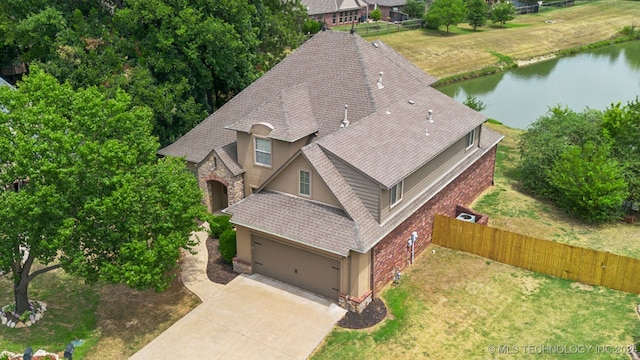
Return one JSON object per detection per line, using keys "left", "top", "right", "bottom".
{"left": 225, "top": 127, "right": 503, "bottom": 256}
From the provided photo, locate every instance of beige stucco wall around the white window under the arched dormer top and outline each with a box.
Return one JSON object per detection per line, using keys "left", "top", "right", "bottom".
{"left": 237, "top": 124, "right": 307, "bottom": 196}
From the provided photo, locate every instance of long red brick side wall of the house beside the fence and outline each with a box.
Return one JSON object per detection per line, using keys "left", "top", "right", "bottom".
{"left": 373, "top": 147, "right": 496, "bottom": 296}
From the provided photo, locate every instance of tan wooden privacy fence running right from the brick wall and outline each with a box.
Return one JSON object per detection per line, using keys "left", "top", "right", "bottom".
{"left": 432, "top": 215, "right": 640, "bottom": 294}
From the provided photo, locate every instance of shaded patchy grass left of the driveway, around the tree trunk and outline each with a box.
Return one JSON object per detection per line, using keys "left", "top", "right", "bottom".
{"left": 0, "top": 260, "right": 200, "bottom": 360}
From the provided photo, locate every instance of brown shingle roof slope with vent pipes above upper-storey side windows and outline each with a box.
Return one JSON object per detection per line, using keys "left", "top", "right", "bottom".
{"left": 318, "top": 86, "right": 486, "bottom": 189}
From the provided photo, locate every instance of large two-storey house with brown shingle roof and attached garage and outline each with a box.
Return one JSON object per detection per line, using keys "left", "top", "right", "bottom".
{"left": 159, "top": 31, "right": 502, "bottom": 311}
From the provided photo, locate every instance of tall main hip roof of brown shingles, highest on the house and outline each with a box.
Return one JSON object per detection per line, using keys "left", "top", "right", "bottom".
{"left": 158, "top": 31, "right": 436, "bottom": 163}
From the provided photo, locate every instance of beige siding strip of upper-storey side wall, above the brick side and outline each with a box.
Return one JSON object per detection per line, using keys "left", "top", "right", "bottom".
{"left": 380, "top": 129, "right": 479, "bottom": 222}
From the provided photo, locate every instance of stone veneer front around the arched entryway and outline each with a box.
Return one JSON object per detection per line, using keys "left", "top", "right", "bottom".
{"left": 198, "top": 152, "right": 244, "bottom": 211}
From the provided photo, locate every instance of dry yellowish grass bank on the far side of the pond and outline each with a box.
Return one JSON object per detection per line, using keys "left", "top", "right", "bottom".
{"left": 378, "top": 0, "right": 640, "bottom": 78}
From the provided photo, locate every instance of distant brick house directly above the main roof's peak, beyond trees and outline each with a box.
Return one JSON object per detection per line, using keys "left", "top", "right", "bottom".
{"left": 300, "top": 0, "right": 367, "bottom": 28}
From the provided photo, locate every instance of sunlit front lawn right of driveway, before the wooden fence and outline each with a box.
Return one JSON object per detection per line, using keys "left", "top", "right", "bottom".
{"left": 312, "top": 246, "right": 640, "bottom": 359}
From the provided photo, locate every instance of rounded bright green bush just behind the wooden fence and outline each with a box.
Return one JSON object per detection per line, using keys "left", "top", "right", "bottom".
{"left": 546, "top": 141, "right": 627, "bottom": 222}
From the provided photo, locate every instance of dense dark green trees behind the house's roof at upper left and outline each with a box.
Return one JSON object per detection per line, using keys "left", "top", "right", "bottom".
{"left": 0, "top": 0, "right": 306, "bottom": 145}
